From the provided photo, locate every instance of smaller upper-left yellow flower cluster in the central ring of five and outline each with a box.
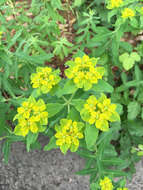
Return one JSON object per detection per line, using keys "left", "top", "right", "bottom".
{"left": 31, "top": 67, "right": 61, "bottom": 94}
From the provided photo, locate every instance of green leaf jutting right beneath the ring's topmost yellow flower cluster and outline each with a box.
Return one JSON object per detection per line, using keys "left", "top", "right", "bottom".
{"left": 91, "top": 80, "right": 114, "bottom": 93}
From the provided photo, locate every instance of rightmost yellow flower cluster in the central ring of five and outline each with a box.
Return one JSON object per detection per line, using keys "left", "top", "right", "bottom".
{"left": 80, "top": 94, "right": 120, "bottom": 131}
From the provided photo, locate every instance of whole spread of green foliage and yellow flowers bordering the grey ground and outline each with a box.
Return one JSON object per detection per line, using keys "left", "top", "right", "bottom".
{"left": 0, "top": 0, "right": 143, "bottom": 190}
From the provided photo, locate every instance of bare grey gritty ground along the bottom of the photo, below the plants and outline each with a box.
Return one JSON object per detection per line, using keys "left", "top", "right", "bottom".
{"left": 0, "top": 140, "right": 143, "bottom": 190}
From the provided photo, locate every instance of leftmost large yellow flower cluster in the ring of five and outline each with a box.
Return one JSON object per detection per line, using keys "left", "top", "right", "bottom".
{"left": 14, "top": 97, "right": 48, "bottom": 136}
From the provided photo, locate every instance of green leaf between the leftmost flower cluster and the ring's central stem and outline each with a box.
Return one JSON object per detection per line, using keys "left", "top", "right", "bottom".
{"left": 46, "top": 103, "right": 64, "bottom": 118}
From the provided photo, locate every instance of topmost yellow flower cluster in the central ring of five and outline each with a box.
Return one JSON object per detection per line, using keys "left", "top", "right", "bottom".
{"left": 65, "top": 55, "right": 105, "bottom": 91}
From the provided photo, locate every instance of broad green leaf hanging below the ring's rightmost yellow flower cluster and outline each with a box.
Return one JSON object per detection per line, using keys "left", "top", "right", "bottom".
{"left": 84, "top": 124, "right": 99, "bottom": 150}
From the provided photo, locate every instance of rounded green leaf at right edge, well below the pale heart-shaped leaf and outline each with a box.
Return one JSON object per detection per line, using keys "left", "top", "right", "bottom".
{"left": 127, "top": 101, "right": 141, "bottom": 120}
